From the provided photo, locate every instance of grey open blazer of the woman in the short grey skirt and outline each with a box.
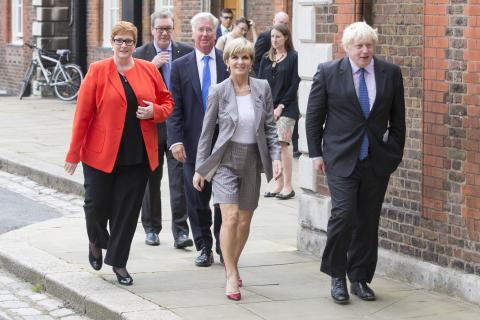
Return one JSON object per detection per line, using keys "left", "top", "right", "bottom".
{"left": 195, "top": 77, "right": 280, "bottom": 181}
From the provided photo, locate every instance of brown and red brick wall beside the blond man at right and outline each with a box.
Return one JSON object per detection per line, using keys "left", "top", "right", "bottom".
{"left": 316, "top": 0, "right": 480, "bottom": 275}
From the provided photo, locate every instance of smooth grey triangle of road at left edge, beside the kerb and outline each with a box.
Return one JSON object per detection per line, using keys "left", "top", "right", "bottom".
{"left": 0, "top": 187, "right": 61, "bottom": 234}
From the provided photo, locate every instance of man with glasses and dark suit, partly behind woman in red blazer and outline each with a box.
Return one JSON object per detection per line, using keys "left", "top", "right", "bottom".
{"left": 133, "top": 11, "right": 193, "bottom": 249}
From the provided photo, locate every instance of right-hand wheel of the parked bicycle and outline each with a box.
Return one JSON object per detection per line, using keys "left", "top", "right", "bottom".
{"left": 52, "top": 63, "right": 83, "bottom": 101}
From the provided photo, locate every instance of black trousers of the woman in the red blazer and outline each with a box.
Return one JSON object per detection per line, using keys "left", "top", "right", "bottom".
{"left": 83, "top": 164, "right": 150, "bottom": 267}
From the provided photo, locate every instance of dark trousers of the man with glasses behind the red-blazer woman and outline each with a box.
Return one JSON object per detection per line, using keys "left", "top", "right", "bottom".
{"left": 142, "top": 142, "right": 189, "bottom": 239}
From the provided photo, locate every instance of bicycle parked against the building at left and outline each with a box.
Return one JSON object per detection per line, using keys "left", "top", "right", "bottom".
{"left": 19, "top": 43, "right": 83, "bottom": 101}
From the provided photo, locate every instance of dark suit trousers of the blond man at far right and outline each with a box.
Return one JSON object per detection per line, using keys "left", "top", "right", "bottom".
{"left": 320, "top": 158, "right": 390, "bottom": 282}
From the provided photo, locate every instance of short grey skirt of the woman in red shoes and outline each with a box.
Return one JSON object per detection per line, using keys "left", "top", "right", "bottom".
{"left": 212, "top": 142, "right": 262, "bottom": 211}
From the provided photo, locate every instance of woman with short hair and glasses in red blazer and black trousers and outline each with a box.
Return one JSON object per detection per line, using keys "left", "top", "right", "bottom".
{"left": 65, "top": 21, "right": 173, "bottom": 285}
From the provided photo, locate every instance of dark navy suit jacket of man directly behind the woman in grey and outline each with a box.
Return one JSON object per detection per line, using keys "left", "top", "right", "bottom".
{"left": 167, "top": 49, "right": 228, "bottom": 163}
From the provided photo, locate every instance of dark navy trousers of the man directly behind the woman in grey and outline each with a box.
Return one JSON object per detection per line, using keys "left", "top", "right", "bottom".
{"left": 183, "top": 163, "right": 222, "bottom": 253}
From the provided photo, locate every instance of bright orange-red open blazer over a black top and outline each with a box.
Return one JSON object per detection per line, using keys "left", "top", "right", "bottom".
{"left": 66, "top": 58, "right": 174, "bottom": 173}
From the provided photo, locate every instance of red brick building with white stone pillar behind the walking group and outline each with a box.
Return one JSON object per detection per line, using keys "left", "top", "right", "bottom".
{"left": 0, "top": 0, "right": 480, "bottom": 302}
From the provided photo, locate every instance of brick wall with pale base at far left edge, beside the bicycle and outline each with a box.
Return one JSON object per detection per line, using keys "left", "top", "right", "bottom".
{"left": 0, "top": 0, "right": 35, "bottom": 94}
